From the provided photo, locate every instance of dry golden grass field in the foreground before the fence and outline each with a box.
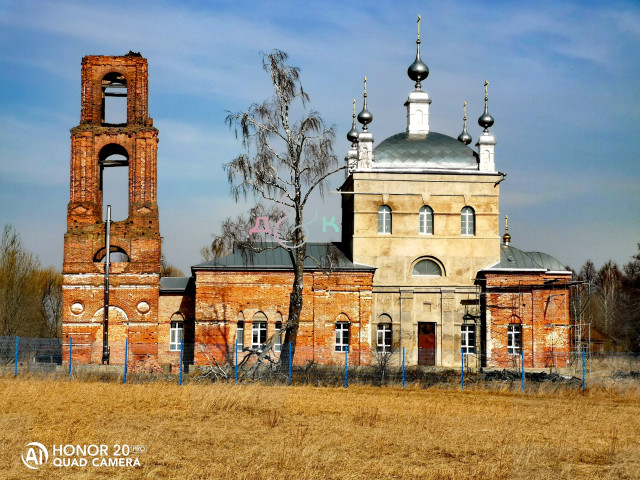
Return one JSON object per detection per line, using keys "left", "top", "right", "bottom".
{"left": 0, "top": 377, "right": 640, "bottom": 480}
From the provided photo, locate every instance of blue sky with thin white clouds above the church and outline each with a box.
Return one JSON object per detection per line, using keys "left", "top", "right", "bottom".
{"left": 0, "top": 0, "right": 640, "bottom": 273}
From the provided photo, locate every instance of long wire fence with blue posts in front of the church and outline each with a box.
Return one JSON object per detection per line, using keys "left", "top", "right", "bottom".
{"left": 0, "top": 337, "right": 640, "bottom": 391}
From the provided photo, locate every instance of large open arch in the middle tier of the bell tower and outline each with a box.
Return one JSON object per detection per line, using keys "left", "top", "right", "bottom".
{"left": 98, "top": 143, "right": 129, "bottom": 221}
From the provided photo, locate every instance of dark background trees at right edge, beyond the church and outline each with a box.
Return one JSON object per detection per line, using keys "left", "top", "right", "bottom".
{"left": 572, "top": 243, "right": 640, "bottom": 352}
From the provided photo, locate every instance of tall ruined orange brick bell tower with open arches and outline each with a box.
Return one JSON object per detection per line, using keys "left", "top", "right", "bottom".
{"left": 62, "top": 52, "right": 161, "bottom": 363}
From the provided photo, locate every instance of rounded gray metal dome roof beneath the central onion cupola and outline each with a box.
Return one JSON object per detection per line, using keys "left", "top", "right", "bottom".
{"left": 373, "top": 132, "right": 478, "bottom": 170}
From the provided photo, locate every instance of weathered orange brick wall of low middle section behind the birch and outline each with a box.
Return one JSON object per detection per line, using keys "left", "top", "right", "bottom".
{"left": 195, "top": 271, "right": 373, "bottom": 365}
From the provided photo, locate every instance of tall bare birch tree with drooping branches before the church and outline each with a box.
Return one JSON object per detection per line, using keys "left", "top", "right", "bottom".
{"left": 211, "top": 50, "right": 346, "bottom": 361}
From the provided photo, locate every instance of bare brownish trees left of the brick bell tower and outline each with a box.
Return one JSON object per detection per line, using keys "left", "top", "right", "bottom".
{"left": 0, "top": 225, "right": 62, "bottom": 337}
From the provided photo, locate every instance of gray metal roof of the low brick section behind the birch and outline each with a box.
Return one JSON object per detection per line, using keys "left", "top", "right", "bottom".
{"left": 191, "top": 242, "right": 375, "bottom": 271}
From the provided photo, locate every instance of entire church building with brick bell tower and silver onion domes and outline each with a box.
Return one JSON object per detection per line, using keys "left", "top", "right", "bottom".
{"left": 63, "top": 22, "right": 572, "bottom": 368}
